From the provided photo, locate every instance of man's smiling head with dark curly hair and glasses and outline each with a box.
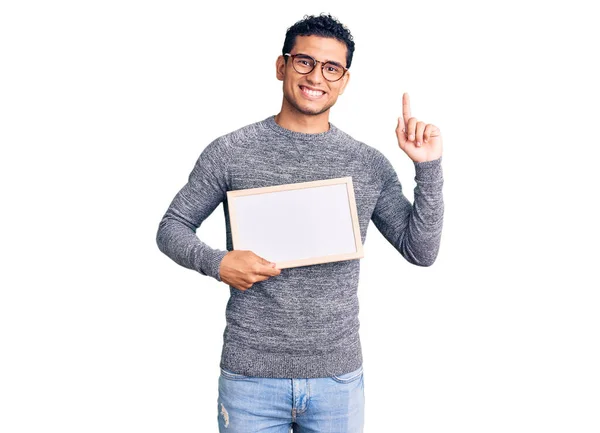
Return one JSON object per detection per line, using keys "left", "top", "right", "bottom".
{"left": 276, "top": 14, "right": 354, "bottom": 115}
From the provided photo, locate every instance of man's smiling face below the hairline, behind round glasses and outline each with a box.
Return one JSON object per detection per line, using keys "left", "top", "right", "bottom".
{"left": 276, "top": 36, "right": 350, "bottom": 115}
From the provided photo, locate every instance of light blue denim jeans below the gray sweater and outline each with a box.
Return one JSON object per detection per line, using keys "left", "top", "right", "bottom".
{"left": 218, "top": 367, "right": 365, "bottom": 433}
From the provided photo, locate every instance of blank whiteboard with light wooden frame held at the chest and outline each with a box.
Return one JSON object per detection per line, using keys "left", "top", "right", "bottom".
{"left": 227, "top": 177, "right": 364, "bottom": 269}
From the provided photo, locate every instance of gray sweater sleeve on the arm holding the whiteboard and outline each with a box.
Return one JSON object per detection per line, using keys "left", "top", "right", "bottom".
{"left": 156, "top": 139, "right": 228, "bottom": 281}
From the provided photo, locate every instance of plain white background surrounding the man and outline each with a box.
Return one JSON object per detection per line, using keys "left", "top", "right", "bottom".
{"left": 0, "top": 0, "right": 600, "bottom": 433}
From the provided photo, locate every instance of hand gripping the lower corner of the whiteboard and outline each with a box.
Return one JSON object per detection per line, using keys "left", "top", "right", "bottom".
{"left": 219, "top": 250, "right": 281, "bottom": 290}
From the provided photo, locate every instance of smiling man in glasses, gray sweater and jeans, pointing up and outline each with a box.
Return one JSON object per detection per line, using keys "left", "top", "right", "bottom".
{"left": 157, "top": 14, "right": 443, "bottom": 433}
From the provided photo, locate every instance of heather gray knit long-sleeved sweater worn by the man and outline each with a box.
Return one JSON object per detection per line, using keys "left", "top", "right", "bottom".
{"left": 156, "top": 116, "right": 444, "bottom": 378}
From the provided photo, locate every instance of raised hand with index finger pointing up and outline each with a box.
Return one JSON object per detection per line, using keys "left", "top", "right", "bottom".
{"left": 396, "top": 93, "right": 442, "bottom": 162}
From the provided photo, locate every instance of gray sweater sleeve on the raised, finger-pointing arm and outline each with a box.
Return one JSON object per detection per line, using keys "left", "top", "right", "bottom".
{"left": 371, "top": 154, "right": 444, "bottom": 266}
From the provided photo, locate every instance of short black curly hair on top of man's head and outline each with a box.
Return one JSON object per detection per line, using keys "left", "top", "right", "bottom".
{"left": 281, "top": 13, "right": 354, "bottom": 68}
